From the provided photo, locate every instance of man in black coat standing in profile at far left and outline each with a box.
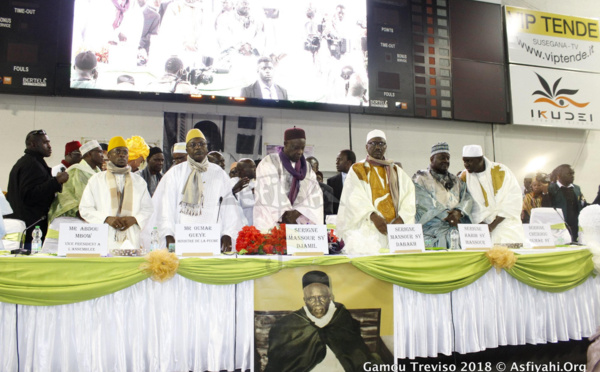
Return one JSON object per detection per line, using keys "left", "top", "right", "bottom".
{"left": 6, "top": 129, "right": 69, "bottom": 243}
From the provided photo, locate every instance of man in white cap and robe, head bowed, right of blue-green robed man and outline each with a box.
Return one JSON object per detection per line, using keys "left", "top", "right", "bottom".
{"left": 461, "top": 145, "right": 523, "bottom": 244}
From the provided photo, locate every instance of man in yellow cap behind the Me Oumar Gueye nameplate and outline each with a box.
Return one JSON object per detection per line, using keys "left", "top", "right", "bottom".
{"left": 152, "top": 129, "right": 242, "bottom": 250}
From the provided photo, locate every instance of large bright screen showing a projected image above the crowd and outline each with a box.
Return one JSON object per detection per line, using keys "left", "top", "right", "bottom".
{"left": 71, "top": 0, "right": 369, "bottom": 105}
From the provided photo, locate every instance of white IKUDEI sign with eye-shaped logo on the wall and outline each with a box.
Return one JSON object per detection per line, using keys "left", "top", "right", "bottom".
{"left": 510, "top": 65, "right": 600, "bottom": 129}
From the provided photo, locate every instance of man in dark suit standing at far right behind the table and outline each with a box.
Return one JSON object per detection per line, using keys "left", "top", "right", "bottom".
{"left": 548, "top": 164, "right": 587, "bottom": 242}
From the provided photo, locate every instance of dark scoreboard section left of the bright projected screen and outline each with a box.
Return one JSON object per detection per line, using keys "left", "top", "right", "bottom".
{"left": 0, "top": 0, "right": 59, "bottom": 95}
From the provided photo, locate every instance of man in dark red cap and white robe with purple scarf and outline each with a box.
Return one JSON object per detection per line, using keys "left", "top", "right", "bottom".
{"left": 254, "top": 127, "right": 323, "bottom": 232}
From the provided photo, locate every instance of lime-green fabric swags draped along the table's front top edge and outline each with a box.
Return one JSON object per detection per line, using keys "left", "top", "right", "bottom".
{"left": 0, "top": 250, "right": 593, "bottom": 306}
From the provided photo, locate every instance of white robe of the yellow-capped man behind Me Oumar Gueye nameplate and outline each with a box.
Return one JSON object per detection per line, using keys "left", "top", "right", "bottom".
{"left": 152, "top": 162, "right": 243, "bottom": 244}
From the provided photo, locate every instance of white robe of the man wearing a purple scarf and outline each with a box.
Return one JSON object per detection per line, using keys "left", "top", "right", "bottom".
{"left": 254, "top": 154, "right": 323, "bottom": 232}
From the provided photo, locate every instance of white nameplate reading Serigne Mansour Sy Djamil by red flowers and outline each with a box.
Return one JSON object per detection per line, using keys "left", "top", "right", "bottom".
{"left": 285, "top": 224, "right": 329, "bottom": 256}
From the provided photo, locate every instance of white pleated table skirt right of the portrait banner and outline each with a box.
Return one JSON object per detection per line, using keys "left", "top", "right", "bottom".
{"left": 394, "top": 269, "right": 600, "bottom": 359}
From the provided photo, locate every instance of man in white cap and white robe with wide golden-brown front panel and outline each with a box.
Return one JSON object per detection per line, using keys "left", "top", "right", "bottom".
{"left": 337, "top": 130, "right": 416, "bottom": 254}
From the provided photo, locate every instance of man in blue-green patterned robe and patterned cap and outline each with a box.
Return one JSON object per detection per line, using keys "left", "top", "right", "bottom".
{"left": 413, "top": 142, "right": 473, "bottom": 248}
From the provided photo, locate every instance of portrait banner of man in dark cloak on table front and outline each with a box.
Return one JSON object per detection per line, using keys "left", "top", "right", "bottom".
{"left": 254, "top": 264, "right": 394, "bottom": 372}
